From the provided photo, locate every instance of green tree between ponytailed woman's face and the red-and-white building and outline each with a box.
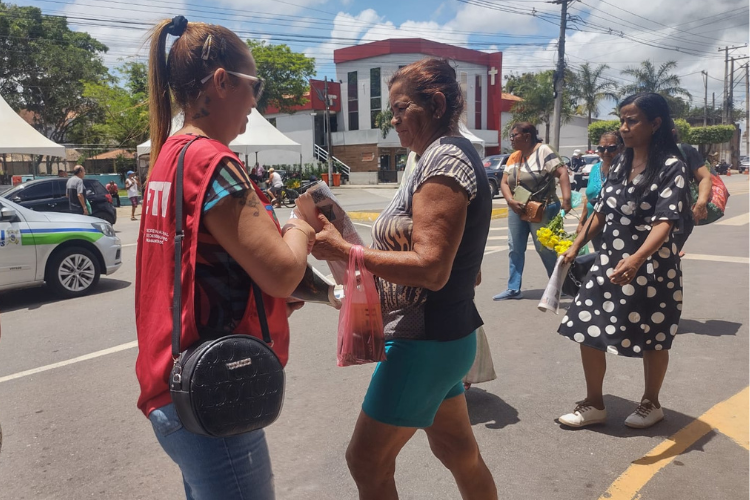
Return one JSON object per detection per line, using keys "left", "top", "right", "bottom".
{"left": 247, "top": 40, "right": 315, "bottom": 113}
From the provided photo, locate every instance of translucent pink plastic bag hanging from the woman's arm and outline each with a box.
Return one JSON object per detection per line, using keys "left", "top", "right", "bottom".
{"left": 336, "top": 245, "right": 385, "bottom": 366}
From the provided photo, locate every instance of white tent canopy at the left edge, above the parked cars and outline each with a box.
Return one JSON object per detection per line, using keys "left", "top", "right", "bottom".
{"left": 0, "top": 96, "right": 65, "bottom": 158}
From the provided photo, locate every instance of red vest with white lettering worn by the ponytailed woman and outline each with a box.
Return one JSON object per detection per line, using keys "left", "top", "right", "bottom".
{"left": 135, "top": 135, "right": 289, "bottom": 416}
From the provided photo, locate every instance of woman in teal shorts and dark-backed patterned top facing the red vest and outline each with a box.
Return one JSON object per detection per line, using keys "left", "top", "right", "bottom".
{"left": 313, "top": 59, "right": 497, "bottom": 500}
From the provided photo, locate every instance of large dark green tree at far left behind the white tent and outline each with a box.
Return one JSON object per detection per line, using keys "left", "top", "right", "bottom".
{"left": 0, "top": 2, "right": 108, "bottom": 146}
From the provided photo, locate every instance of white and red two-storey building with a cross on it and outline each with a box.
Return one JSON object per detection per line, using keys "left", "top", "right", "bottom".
{"left": 332, "top": 38, "right": 502, "bottom": 184}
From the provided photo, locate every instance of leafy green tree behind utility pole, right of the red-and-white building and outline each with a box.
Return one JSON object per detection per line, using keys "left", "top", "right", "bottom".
{"left": 506, "top": 71, "right": 573, "bottom": 143}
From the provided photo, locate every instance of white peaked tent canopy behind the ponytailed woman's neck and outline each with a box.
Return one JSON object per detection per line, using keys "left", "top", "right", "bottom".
{"left": 137, "top": 111, "right": 302, "bottom": 157}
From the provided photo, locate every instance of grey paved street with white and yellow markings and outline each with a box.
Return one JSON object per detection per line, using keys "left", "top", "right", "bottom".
{"left": 0, "top": 175, "right": 750, "bottom": 500}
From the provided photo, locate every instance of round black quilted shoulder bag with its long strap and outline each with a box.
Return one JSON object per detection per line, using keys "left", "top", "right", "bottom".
{"left": 169, "top": 138, "right": 284, "bottom": 437}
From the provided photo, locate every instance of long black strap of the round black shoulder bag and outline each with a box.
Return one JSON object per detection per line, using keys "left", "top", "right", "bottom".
{"left": 172, "top": 137, "right": 273, "bottom": 364}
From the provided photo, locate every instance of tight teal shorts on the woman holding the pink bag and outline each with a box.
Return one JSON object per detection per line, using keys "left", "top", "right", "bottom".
{"left": 362, "top": 332, "right": 477, "bottom": 428}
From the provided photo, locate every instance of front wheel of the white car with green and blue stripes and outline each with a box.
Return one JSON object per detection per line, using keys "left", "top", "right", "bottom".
{"left": 47, "top": 247, "right": 101, "bottom": 298}
